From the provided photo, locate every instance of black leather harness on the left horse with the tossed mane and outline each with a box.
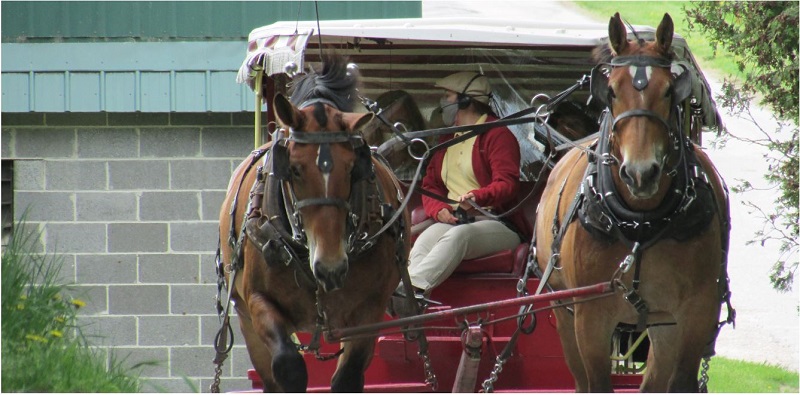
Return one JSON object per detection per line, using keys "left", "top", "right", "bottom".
{"left": 231, "top": 131, "right": 402, "bottom": 289}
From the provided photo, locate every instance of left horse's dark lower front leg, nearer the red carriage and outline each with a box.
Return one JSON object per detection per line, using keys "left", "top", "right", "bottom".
{"left": 331, "top": 338, "right": 375, "bottom": 392}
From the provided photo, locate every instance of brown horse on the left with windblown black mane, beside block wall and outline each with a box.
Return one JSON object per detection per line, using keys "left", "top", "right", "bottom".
{"left": 220, "top": 57, "right": 410, "bottom": 392}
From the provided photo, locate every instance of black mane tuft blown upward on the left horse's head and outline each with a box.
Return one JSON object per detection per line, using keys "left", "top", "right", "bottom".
{"left": 289, "top": 54, "right": 358, "bottom": 112}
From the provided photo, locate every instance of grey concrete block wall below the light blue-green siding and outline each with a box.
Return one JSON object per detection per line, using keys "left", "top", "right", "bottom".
{"left": 1, "top": 113, "right": 260, "bottom": 392}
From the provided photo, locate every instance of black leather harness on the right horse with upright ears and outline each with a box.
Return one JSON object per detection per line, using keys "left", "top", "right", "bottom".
{"left": 537, "top": 56, "right": 736, "bottom": 355}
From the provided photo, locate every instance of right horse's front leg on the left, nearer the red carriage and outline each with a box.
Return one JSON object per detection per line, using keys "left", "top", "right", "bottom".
{"left": 575, "top": 301, "right": 617, "bottom": 392}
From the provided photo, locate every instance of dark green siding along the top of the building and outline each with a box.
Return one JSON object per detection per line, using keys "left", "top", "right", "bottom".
{"left": 0, "top": 1, "right": 422, "bottom": 42}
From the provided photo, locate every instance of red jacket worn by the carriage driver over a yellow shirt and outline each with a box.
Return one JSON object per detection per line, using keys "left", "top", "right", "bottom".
{"left": 422, "top": 115, "right": 533, "bottom": 241}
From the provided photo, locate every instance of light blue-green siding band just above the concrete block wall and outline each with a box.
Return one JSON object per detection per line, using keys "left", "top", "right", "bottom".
{"left": 1, "top": 41, "right": 255, "bottom": 113}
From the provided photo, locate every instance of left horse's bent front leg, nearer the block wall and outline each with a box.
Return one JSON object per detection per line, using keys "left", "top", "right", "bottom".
{"left": 248, "top": 293, "right": 308, "bottom": 392}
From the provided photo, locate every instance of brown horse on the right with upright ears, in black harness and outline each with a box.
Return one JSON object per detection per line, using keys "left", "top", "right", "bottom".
{"left": 535, "top": 14, "right": 730, "bottom": 392}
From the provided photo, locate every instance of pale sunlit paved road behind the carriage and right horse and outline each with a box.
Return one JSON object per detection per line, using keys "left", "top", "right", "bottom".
{"left": 422, "top": 0, "right": 800, "bottom": 371}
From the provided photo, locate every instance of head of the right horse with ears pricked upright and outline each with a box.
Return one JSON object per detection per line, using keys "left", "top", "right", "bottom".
{"left": 592, "top": 13, "right": 691, "bottom": 204}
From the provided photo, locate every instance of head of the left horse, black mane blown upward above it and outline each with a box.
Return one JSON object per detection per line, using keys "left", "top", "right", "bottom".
{"left": 274, "top": 94, "right": 373, "bottom": 291}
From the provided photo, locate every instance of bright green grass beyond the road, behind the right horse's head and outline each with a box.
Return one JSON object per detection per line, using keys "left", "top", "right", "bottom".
{"left": 574, "top": 1, "right": 744, "bottom": 80}
